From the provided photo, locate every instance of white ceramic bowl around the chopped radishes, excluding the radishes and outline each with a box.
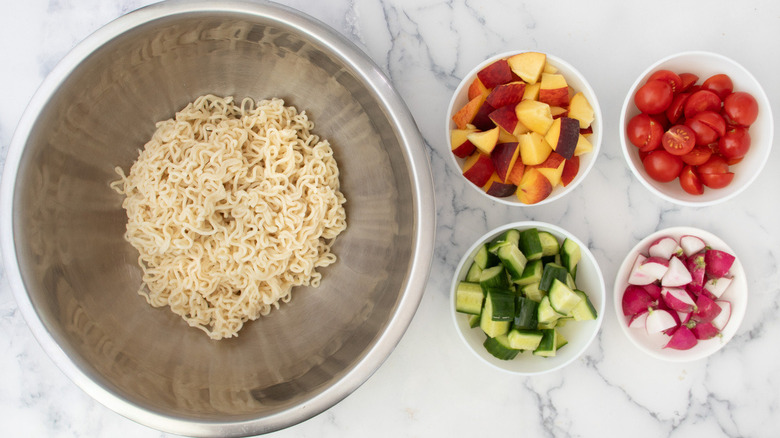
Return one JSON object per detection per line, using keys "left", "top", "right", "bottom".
{"left": 613, "top": 227, "right": 748, "bottom": 362}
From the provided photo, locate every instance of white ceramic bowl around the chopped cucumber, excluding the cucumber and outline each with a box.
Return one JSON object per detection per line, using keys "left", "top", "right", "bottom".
{"left": 450, "top": 221, "right": 606, "bottom": 375}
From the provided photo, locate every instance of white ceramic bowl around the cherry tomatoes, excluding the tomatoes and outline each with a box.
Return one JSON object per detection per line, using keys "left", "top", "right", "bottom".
{"left": 620, "top": 52, "right": 774, "bottom": 207}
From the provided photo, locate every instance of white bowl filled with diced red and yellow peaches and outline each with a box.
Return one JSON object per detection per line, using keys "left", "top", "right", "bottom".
{"left": 446, "top": 51, "right": 602, "bottom": 206}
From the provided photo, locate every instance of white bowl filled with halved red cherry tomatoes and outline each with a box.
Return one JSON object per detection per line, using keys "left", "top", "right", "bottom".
{"left": 620, "top": 52, "right": 774, "bottom": 207}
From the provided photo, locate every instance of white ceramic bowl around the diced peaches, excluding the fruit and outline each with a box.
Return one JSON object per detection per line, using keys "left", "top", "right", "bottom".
{"left": 444, "top": 50, "right": 603, "bottom": 207}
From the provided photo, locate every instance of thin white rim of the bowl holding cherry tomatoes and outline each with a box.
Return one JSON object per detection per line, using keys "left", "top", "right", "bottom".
{"left": 619, "top": 50, "right": 774, "bottom": 207}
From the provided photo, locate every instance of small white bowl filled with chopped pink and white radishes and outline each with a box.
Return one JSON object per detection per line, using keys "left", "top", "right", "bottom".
{"left": 614, "top": 227, "right": 747, "bottom": 362}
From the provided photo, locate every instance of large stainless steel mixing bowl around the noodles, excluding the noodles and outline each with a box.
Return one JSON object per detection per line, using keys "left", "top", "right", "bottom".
{"left": 0, "top": 1, "right": 435, "bottom": 436}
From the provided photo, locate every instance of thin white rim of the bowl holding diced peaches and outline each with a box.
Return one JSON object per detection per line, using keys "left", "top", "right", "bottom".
{"left": 444, "top": 50, "right": 604, "bottom": 207}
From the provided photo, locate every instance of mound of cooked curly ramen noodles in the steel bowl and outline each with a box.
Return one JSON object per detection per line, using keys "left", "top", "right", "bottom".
{"left": 112, "top": 95, "right": 346, "bottom": 339}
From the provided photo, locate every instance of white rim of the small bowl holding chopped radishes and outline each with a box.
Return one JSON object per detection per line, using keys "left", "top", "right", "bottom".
{"left": 612, "top": 226, "right": 748, "bottom": 362}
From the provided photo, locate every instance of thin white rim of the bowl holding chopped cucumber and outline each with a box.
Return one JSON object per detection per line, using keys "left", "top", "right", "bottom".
{"left": 447, "top": 221, "right": 607, "bottom": 376}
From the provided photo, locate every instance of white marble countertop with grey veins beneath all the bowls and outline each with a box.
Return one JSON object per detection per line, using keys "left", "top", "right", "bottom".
{"left": 0, "top": 0, "right": 780, "bottom": 437}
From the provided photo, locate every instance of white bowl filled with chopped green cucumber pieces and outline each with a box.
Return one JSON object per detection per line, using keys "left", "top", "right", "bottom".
{"left": 450, "top": 221, "right": 606, "bottom": 375}
